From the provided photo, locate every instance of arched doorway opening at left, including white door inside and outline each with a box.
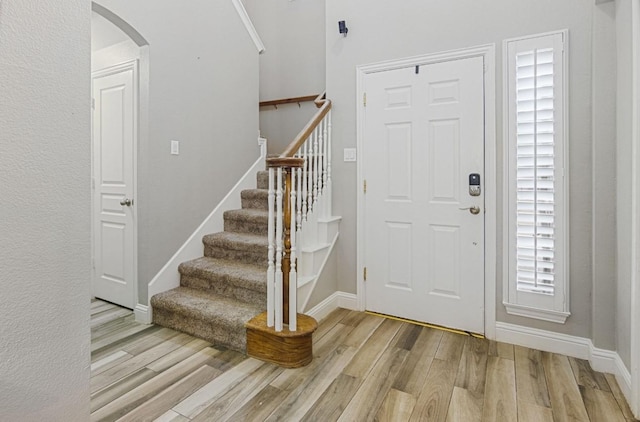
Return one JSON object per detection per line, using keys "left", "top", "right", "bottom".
{"left": 91, "top": 2, "right": 149, "bottom": 309}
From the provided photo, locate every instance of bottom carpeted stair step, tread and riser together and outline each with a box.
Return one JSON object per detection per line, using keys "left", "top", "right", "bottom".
{"left": 151, "top": 287, "right": 264, "bottom": 352}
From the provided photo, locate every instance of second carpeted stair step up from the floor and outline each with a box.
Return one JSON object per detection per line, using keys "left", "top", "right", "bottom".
{"left": 178, "top": 256, "right": 267, "bottom": 294}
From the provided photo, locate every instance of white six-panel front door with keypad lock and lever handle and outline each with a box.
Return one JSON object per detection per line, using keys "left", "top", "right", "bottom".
{"left": 361, "top": 57, "right": 485, "bottom": 333}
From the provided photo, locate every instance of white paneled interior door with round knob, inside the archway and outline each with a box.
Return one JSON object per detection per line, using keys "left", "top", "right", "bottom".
{"left": 92, "top": 62, "right": 137, "bottom": 308}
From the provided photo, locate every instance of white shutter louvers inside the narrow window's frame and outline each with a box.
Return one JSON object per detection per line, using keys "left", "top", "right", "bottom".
{"left": 516, "top": 48, "right": 555, "bottom": 294}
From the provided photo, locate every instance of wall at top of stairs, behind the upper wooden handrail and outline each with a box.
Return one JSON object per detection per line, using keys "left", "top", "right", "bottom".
{"left": 244, "top": 0, "right": 328, "bottom": 153}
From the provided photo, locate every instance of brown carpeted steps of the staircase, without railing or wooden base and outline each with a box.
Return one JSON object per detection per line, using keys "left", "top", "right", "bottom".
{"left": 151, "top": 171, "right": 269, "bottom": 353}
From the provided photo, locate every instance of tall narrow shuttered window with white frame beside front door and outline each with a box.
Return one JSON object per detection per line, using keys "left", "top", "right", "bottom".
{"left": 504, "top": 31, "right": 569, "bottom": 323}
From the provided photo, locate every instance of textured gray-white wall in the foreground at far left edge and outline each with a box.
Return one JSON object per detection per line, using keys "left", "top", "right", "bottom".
{"left": 0, "top": 0, "right": 91, "bottom": 422}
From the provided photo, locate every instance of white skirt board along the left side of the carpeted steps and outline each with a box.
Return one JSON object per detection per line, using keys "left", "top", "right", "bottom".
{"left": 141, "top": 138, "right": 267, "bottom": 324}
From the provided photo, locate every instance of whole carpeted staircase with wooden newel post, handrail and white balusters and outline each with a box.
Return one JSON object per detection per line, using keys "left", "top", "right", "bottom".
{"left": 149, "top": 93, "right": 340, "bottom": 368}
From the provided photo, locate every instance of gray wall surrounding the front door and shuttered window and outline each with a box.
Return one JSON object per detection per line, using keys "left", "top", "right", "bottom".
{"left": 326, "top": 0, "right": 614, "bottom": 342}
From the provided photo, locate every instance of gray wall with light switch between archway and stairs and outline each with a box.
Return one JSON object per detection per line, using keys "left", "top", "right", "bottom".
{"left": 97, "top": 0, "right": 259, "bottom": 303}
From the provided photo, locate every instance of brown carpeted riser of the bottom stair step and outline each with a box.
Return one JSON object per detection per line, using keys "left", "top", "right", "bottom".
{"left": 153, "top": 307, "right": 247, "bottom": 353}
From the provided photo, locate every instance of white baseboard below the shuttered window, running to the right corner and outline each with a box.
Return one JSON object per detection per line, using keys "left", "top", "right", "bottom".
{"left": 496, "top": 322, "right": 631, "bottom": 400}
